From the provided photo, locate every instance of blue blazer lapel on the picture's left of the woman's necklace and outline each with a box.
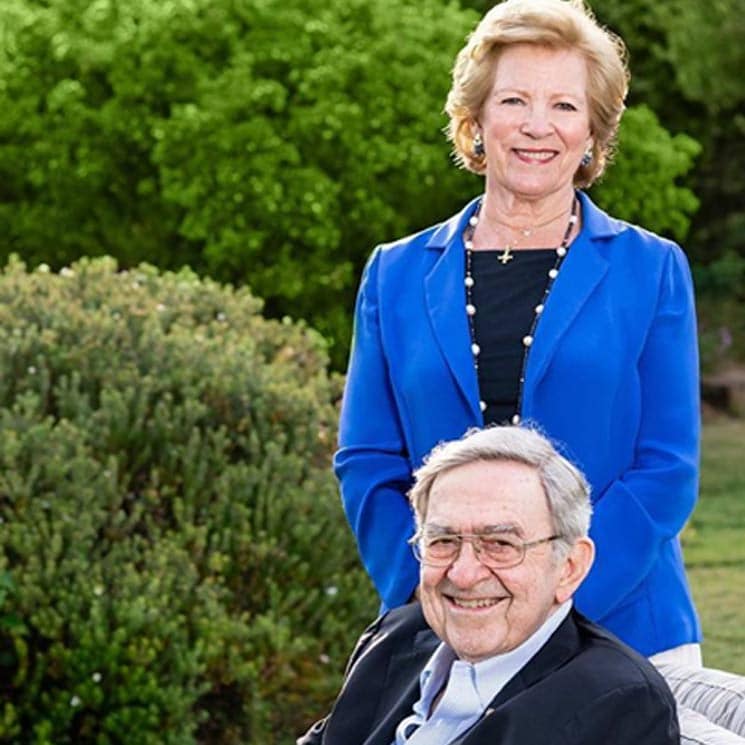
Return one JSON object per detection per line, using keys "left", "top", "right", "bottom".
{"left": 424, "top": 199, "right": 483, "bottom": 423}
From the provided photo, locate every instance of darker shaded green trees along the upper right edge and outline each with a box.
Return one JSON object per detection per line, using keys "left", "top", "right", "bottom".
{"left": 592, "top": 0, "right": 745, "bottom": 369}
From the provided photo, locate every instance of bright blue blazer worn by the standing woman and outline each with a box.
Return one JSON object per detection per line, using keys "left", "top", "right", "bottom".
{"left": 334, "top": 192, "right": 701, "bottom": 655}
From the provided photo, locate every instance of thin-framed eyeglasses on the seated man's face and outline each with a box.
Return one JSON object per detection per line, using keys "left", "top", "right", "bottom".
{"left": 409, "top": 531, "right": 564, "bottom": 569}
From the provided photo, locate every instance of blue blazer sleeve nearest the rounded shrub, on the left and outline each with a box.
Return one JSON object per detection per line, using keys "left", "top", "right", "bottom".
{"left": 334, "top": 248, "right": 419, "bottom": 608}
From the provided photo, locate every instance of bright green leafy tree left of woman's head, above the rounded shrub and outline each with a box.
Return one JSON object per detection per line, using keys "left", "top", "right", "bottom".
{"left": 0, "top": 0, "right": 473, "bottom": 364}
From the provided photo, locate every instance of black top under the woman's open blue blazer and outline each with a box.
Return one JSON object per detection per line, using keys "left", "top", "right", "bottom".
{"left": 471, "top": 248, "right": 556, "bottom": 424}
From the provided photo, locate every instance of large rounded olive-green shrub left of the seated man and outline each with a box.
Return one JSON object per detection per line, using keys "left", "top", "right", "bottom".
{"left": 0, "top": 259, "right": 374, "bottom": 745}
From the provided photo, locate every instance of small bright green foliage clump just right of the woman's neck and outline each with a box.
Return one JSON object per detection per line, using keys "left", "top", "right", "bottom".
{"left": 593, "top": 105, "right": 701, "bottom": 240}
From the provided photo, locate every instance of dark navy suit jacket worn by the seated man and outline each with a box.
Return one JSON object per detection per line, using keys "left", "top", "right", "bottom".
{"left": 297, "top": 603, "right": 680, "bottom": 745}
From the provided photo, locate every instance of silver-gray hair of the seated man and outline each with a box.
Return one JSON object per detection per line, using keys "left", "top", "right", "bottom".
{"left": 409, "top": 426, "right": 592, "bottom": 545}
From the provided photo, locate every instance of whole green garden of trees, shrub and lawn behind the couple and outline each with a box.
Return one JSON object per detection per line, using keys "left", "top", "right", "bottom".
{"left": 0, "top": 0, "right": 745, "bottom": 745}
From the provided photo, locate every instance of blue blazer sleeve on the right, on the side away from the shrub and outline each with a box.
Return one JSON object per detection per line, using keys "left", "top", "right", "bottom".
{"left": 577, "top": 245, "right": 700, "bottom": 620}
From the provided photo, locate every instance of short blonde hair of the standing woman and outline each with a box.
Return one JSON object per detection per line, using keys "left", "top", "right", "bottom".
{"left": 445, "top": 0, "right": 629, "bottom": 187}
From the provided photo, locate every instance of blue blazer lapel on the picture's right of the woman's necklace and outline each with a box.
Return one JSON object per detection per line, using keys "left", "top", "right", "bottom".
{"left": 522, "top": 192, "right": 625, "bottom": 398}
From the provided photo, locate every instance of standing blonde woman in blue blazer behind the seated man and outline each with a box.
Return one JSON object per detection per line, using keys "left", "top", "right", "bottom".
{"left": 335, "top": 0, "right": 744, "bottom": 740}
